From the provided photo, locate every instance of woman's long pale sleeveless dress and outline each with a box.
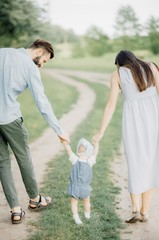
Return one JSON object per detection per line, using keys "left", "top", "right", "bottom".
{"left": 119, "top": 67, "right": 159, "bottom": 194}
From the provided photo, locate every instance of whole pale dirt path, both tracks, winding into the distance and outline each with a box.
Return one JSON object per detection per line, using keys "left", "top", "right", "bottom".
{"left": 0, "top": 70, "right": 159, "bottom": 240}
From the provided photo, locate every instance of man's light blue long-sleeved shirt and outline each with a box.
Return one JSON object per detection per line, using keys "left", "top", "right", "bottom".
{"left": 0, "top": 48, "right": 63, "bottom": 135}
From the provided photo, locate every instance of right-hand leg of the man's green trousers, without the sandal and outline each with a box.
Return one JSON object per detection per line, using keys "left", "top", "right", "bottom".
{"left": 1, "top": 118, "right": 38, "bottom": 199}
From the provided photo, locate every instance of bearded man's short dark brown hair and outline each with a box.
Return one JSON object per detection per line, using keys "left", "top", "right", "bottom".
{"left": 28, "top": 39, "right": 54, "bottom": 59}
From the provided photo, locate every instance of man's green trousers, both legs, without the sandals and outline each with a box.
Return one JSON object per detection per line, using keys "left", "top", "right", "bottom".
{"left": 0, "top": 118, "right": 38, "bottom": 208}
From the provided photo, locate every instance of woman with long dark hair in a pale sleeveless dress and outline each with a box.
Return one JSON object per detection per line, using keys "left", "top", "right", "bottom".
{"left": 93, "top": 50, "right": 159, "bottom": 223}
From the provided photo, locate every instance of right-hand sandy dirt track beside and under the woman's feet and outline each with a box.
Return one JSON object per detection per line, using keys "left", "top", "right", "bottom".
{"left": 112, "top": 146, "right": 159, "bottom": 240}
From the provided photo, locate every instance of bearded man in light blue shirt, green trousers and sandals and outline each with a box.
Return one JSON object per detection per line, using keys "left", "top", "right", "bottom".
{"left": 0, "top": 39, "right": 69, "bottom": 224}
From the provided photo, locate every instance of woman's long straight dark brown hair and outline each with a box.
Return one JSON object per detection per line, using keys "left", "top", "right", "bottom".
{"left": 115, "top": 50, "right": 155, "bottom": 92}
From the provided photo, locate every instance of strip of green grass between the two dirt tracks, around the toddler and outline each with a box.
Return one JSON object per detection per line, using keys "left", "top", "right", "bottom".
{"left": 28, "top": 76, "right": 123, "bottom": 240}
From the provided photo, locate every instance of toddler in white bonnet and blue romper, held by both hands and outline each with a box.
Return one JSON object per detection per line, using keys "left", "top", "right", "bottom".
{"left": 63, "top": 138, "right": 99, "bottom": 224}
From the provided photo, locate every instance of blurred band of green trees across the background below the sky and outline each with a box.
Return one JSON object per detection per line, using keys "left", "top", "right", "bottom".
{"left": 0, "top": 0, "right": 159, "bottom": 58}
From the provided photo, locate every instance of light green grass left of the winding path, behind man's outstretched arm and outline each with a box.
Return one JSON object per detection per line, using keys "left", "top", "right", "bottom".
{"left": 18, "top": 73, "right": 79, "bottom": 142}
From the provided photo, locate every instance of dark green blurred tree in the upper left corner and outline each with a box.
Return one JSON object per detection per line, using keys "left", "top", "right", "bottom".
{"left": 0, "top": 0, "right": 40, "bottom": 46}
